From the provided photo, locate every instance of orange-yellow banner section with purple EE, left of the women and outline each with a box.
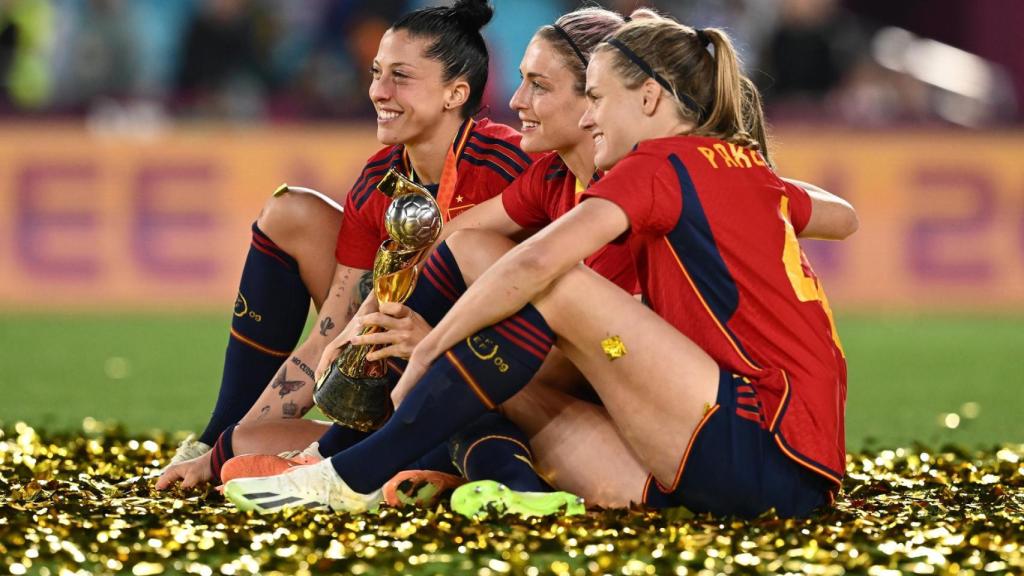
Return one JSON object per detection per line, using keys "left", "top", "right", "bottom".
{"left": 0, "top": 124, "right": 378, "bottom": 310}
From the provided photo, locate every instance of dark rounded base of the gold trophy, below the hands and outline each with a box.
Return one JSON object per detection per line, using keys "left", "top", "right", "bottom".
{"left": 313, "top": 363, "right": 394, "bottom": 431}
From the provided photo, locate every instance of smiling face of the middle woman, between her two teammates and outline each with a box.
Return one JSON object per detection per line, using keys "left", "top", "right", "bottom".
{"left": 509, "top": 36, "right": 588, "bottom": 153}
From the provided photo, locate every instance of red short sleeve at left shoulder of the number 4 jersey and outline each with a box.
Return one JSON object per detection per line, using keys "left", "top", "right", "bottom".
{"left": 584, "top": 152, "right": 682, "bottom": 236}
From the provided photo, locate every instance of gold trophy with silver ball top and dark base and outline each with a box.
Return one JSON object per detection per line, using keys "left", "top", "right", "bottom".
{"left": 313, "top": 168, "right": 442, "bottom": 431}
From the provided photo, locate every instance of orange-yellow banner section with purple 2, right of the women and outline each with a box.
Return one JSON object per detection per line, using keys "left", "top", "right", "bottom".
{"left": 775, "top": 130, "right": 1024, "bottom": 311}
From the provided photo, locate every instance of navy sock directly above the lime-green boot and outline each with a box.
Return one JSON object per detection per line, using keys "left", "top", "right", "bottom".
{"left": 449, "top": 412, "right": 551, "bottom": 492}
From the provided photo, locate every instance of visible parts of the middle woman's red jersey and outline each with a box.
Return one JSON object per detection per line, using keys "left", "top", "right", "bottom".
{"left": 502, "top": 152, "right": 639, "bottom": 294}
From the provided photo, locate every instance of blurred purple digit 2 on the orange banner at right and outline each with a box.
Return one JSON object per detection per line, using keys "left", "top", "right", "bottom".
{"left": 907, "top": 167, "right": 995, "bottom": 284}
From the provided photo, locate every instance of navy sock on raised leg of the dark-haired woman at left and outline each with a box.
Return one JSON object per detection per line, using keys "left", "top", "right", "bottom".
{"left": 200, "top": 222, "right": 309, "bottom": 444}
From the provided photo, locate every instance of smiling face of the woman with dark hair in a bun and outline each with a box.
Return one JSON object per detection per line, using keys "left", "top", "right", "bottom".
{"left": 370, "top": 30, "right": 450, "bottom": 145}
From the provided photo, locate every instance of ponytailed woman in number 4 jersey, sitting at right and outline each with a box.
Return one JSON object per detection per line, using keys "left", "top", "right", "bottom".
{"left": 225, "top": 12, "right": 856, "bottom": 516}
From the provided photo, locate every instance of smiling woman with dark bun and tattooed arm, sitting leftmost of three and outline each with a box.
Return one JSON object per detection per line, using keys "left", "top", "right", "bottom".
{"left": 158, "top": 0, "right": 532, "bottom": 488}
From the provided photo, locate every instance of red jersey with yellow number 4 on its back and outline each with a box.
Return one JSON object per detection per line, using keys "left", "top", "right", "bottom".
{"left": 584, "top": 136, "right": 846, "bottom": 484}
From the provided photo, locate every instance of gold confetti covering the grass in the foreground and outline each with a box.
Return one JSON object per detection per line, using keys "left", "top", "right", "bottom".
{"left": 0, "top": 421, "right": 1024, "bottom": 576}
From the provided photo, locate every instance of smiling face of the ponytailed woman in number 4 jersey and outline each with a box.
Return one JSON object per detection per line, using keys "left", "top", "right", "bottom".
{"left": 580, "top": 50, "right": 649, "bottom": 170}
